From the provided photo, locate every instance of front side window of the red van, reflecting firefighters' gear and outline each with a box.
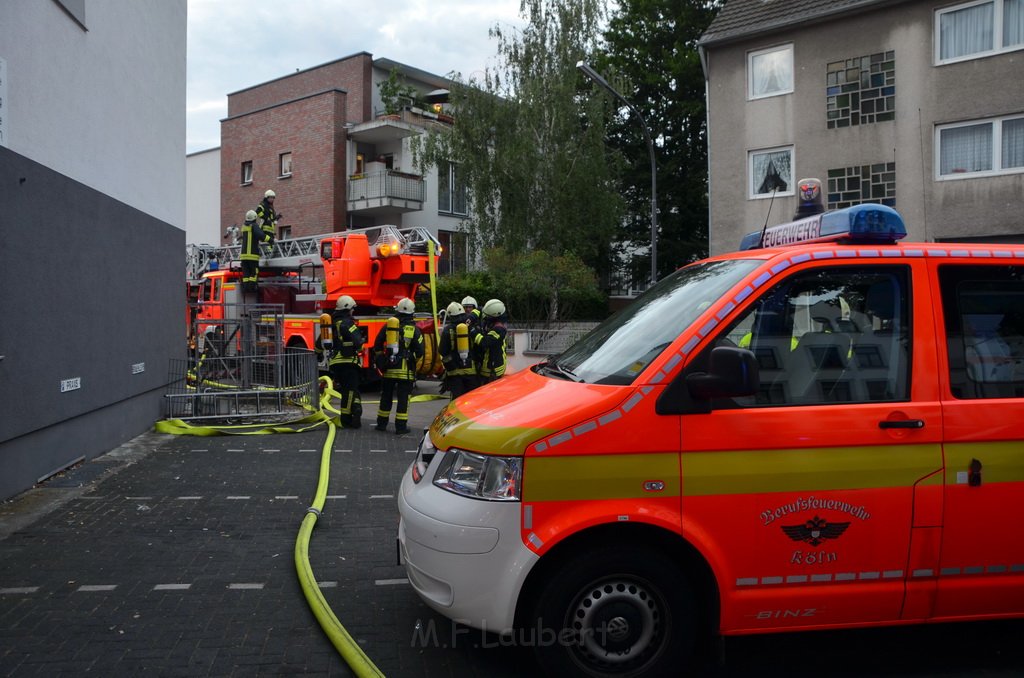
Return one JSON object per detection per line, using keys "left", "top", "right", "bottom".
{"left": 697, "top": 265, "right": 911, "bottom": 408}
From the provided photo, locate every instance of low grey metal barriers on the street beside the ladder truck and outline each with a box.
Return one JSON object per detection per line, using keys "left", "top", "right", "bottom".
{"left": 165, "top": 349, "right": 319, "bottom": 423}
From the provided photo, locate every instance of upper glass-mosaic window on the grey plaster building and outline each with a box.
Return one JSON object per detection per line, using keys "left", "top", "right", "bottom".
{"left": 825, "top": 51, "right": 896, "bottom": 129}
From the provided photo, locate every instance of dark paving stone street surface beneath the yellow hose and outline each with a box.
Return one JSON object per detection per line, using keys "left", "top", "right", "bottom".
{"left": 0, "top": 382, "right": 537, "bottom": 676}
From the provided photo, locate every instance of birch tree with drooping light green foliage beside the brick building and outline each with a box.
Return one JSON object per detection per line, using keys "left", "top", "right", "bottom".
{"left": 414, "top": 0, "right": 623, "bottom": 278}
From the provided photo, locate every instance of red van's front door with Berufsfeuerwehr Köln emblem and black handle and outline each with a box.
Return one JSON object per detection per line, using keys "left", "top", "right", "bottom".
{"left": 673, "top": 262, "right": 942, "bottom": 633}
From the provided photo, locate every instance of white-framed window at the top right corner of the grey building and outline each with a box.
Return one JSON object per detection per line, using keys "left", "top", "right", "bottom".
{"left": 935, "top": 0, "right": 1024, "bottom": 63}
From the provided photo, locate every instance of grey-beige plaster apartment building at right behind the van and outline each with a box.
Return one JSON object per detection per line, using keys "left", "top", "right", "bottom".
{"left": 699, "top": 0, "right": 1024, "bottom": 253}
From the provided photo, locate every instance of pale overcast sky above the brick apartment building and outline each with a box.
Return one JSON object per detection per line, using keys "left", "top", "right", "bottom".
{"left": 186, "top": 0, "right": 523, "bottom": 153}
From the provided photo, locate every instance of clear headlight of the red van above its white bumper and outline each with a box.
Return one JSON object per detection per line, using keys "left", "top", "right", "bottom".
{"left": 434, "top": 448, "right": 522, "bottom": 502}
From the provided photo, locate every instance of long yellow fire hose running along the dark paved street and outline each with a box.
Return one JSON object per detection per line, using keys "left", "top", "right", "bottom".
{"left": 156, "top": 377, "right": 384, "bottom": 678}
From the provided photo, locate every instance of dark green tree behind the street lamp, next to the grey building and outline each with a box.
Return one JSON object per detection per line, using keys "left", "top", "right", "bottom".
{"left": 594, "top": 0, "right": 722, "bottom": 279}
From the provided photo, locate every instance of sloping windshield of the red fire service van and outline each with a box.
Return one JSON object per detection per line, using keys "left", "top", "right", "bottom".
{"left": 548, "top": 259, "right": 761, "bottom": 385}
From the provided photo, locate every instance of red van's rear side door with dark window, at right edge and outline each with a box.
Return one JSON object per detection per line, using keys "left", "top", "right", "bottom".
{"left": 934, "top": 259, "right": 1024, "bottom": 618}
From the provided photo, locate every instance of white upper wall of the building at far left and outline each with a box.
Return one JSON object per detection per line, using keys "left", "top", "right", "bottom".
{"left": 0, "top": 0, "right": 186, "bottom": 228}
